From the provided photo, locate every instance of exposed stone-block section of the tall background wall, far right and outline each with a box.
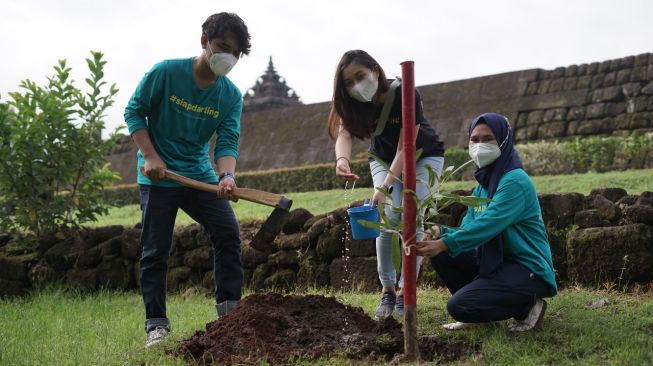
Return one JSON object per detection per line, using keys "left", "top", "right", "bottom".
{"left": 515, "top": 54, "right": 653, "bottom": 141}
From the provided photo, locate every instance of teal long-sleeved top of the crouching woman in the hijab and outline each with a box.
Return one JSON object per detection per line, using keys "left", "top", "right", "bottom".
{"left": 442, "top": 169, "right": 558, "bottom": 296}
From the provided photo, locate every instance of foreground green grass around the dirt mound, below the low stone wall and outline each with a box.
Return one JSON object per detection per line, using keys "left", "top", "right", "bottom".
{"left": 0, "top": 288, "right": 653, "bottom": 365}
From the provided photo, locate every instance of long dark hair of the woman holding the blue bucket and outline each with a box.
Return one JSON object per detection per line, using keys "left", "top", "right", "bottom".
{"left": 328, "top": 50, "right": 388, "bottom": 140}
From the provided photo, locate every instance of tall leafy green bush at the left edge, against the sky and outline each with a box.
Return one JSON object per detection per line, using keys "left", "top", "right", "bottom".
{"left": 0, "top": 52, "right": 118, "bottom": 235}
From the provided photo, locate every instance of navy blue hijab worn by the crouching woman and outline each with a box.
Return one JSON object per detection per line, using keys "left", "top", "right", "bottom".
{"left": 469, "top": 113, "right": 522, "bottom": 277}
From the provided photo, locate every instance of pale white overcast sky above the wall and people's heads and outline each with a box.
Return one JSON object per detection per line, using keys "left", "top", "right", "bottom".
{"left": 0, "top": 0, "right": 653, "bottom": 136}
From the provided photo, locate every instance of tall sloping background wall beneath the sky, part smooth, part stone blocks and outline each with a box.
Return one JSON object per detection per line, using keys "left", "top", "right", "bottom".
{"left": 103, "top": 53, "right": 653, "bottom": 183}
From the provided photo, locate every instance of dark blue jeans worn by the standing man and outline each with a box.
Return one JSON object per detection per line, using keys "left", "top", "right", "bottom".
{"left": 140, "top": 185, "right": 243, "bottom": 331}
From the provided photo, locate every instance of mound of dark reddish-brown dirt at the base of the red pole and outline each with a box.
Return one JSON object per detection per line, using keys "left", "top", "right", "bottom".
{"left": 169, "top": 294, "right": 470, "bottom": 365}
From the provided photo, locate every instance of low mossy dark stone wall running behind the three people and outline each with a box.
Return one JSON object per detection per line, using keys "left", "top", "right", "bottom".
{"left": 0, "top": 188, "right": 653, "bottom": 296}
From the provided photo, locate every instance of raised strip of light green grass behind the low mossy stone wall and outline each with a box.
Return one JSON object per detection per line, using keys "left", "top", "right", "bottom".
{"left": 88, "top": 169, "right": 653, "bottom": 226}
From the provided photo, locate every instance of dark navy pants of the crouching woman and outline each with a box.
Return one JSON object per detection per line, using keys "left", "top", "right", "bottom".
{"left": 431, "top": 252, "right": 551, "bottom": 323}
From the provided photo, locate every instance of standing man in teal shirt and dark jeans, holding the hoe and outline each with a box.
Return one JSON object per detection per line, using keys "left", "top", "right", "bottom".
{"left": 125, "top": 13, "right": 251, "bottom": 347}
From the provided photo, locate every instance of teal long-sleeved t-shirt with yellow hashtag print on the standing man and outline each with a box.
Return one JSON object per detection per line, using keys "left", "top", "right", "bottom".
{"left": 125, "top": 58, "right": 243, "bottom": 187}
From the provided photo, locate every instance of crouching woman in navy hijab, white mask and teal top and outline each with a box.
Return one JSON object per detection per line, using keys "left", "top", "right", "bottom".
{"left": 417, "top": 113, "right": 557, "bottom": 331}
